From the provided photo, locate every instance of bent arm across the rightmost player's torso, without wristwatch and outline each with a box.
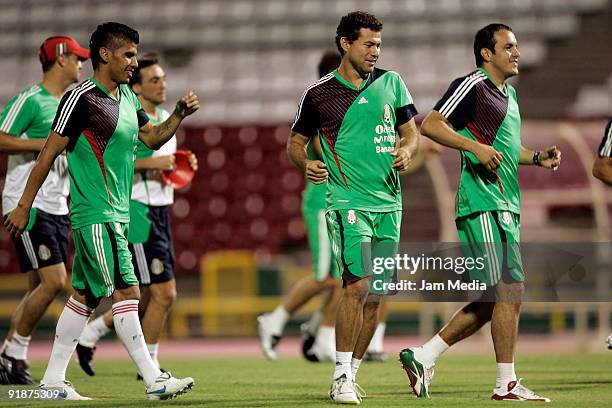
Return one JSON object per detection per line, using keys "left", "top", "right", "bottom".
{"left": 421, "top": 110, "right": 502, "bottom": 171}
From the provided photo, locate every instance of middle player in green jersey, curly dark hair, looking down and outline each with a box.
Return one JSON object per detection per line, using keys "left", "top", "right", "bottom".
{"left": 287, "top": 12, "right": 419, "bottom": 404}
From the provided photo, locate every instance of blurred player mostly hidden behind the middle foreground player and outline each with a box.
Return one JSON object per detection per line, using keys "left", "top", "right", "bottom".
{"left": 257, "top": 51, "right": 341, "bottom": 361}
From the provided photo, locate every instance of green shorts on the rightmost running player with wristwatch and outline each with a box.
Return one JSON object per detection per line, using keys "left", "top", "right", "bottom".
{"left": 455, "top": 211, "right": 525, "bottom": 287}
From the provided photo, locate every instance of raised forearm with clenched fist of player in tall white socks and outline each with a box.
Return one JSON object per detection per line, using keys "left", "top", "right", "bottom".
{"left": 138, "top": 91, "right": 200, "bottom": 150}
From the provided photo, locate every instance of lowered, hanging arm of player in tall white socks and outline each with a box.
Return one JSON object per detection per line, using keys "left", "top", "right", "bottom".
{"left": 4, "top": 131, "right": 68, "bottom": 236}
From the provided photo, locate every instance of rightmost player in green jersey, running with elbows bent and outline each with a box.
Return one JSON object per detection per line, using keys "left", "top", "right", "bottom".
{"left": 400, "top": 24, "right": 561, "bottom": 402}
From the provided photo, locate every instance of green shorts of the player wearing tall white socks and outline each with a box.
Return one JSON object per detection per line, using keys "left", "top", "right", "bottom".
{"left": 72, "top": 222, "right": 138, "bottom": 298}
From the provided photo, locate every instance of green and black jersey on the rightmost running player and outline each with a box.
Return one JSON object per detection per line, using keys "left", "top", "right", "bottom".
{"left": 434, "top": 68, "right": 521, "bottom": 218}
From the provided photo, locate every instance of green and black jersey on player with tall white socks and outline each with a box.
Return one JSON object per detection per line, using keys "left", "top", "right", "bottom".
{"left": 52, "top": 78, "right": 149, "bottom": 228}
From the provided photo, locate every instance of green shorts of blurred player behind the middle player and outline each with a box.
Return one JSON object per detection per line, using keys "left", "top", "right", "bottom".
{"left": 302, "top": 208, "right": 340, "bottom": 282}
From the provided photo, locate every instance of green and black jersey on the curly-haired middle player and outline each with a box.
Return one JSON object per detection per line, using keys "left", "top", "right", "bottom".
{"left": 292, "top": 68, "right": 417, "bottom": 212}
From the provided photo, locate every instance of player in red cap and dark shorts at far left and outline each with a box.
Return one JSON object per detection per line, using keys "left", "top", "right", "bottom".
{"left": 0, "top": 35, "right": 89, "bottom": 384}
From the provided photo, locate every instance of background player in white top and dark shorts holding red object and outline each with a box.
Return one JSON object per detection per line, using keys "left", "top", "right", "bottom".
{"left": 76, "top": 53, "right": 198, "bottom": 379}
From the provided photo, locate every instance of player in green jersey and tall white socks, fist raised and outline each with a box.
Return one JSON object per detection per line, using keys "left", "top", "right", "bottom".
{"left": 5, "top": 23, "right": 199, "bottom": 399}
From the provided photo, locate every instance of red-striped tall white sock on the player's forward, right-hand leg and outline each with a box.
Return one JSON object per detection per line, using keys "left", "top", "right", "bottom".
{"left": 113, "top": 300, "right": 161, "bottom": 387}
